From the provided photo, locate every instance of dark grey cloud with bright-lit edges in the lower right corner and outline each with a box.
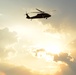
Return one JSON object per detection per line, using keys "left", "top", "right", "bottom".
{"left": 54, "top": 53, "right": 76, "bottom": 75}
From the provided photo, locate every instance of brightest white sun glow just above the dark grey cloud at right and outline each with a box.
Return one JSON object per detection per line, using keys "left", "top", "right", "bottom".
{"left": 34, "top": 40, "right": 65, "bottom": 54}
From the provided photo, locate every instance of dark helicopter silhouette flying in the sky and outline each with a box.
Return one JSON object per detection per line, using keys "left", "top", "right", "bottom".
{"left": 26, "top": 9, "right": 51, "bottom": 19}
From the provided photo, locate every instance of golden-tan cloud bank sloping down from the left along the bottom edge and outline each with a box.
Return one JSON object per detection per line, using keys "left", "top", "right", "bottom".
{"left": 0, "top": 63, "right": 50, "bottom": 75}
